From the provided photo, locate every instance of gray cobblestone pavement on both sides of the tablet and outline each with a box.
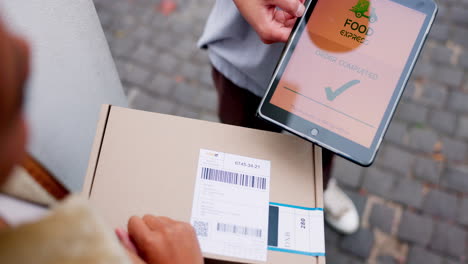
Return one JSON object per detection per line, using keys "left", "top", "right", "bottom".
{"left": 95, "top": 0, "right": 468, "bottom": 264}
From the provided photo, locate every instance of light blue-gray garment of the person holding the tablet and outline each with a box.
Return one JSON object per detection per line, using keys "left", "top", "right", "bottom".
{"left": 198, "top": 0, "right": 284, "bottom": 97}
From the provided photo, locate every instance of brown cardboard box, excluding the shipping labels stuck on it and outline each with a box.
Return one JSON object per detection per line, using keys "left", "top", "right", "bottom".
{"left": 83, "top": 105, "right": 325, "bottom": 264}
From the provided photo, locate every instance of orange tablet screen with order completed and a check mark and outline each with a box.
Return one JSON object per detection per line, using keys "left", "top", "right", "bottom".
{"left": 270, "top": 0, "right": 426, "bottom": 148}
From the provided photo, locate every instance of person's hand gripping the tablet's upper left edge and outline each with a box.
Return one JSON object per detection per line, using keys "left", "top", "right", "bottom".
{"left": 233, "top": 0, "right": 305, "bottom": 44}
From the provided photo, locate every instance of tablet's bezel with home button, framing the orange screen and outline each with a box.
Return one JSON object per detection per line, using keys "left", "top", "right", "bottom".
{"left": 257, "top": 0, "right": 438, "bottom": 166}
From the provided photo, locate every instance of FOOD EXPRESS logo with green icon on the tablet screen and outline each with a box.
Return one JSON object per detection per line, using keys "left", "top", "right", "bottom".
{"left": 340, "top": 0, "right": 378, "bottom": 45}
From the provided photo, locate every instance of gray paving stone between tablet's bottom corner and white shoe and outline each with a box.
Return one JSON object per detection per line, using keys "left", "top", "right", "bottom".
{"left": 332, "top": 158, "right": 363, "bottom": 188}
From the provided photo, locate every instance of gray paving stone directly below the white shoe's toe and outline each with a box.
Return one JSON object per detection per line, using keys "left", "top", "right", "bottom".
{"left": 341, "top": 229, "right": 374, "bottom": 259}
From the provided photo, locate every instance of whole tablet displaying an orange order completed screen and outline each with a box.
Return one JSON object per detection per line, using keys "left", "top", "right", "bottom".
{"left": 257, "top": 0, "right": 437, "bottom": 166}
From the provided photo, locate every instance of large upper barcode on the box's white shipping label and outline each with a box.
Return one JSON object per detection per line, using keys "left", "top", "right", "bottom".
{"left": 201, "top": 168, "right": 267, "bottom": 190}
